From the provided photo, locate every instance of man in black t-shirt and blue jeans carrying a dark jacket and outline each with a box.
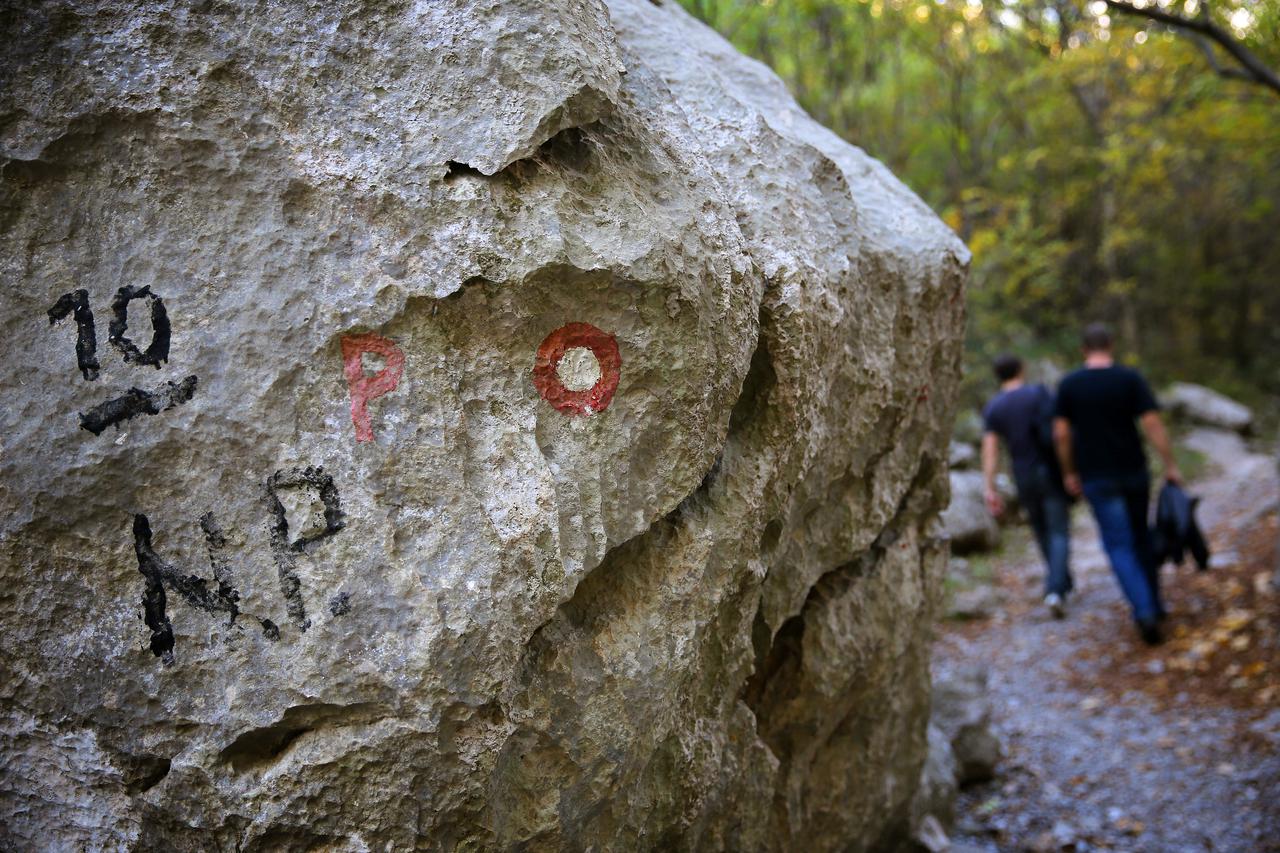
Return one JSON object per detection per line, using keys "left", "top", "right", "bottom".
{"left": 1053, "top": 323, "right": 1181, "bottom": 644}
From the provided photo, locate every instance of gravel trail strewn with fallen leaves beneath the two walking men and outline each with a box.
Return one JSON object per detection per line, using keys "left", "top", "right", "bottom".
{"left": 934, "top": 430, "right": 1280, "bottom": 852}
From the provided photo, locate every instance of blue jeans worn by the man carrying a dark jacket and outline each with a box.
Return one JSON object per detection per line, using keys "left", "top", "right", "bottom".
{"left": 1083, "top": 471, "right": 1165, "bottom": 621}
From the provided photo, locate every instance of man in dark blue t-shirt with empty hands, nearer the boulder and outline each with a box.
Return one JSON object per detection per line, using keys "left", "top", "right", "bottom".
{"left": 982, "top": 355, "right": 1071, "bottom": 619}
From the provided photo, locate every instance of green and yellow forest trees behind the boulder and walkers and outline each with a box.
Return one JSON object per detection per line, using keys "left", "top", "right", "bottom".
{"left": 681, "top": 0, "right": 1280, "bottom": 423}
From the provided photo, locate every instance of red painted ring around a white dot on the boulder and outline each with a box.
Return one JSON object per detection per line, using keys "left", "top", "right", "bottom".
{"left": 534, "top": 323, "right": 622, "bottom": 418}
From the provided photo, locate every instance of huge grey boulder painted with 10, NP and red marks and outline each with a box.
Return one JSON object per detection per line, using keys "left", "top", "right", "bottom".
{"left": 0, "top": 0, "right": 968, "bottom": 850}
